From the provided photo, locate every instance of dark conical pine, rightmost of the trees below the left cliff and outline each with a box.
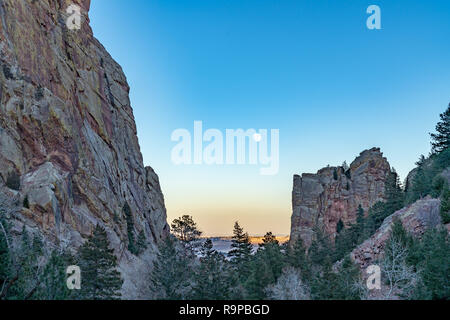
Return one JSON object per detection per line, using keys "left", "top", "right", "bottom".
{"left": 79, "top": 225, "right": 123, "bottom": 300}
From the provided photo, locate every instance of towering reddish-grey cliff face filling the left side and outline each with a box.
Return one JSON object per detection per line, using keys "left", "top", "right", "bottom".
{"left": 0, "top": 0, "right": 169, "bottom": 298}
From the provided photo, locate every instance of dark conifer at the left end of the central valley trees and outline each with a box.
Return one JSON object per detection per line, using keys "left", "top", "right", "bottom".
{"left": 150, "top": 236, "right": 192, "bottom": 300}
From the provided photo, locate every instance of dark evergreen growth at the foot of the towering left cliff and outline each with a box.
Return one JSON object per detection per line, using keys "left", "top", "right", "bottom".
{"left": 0, "top": 215, "right": 122, "bottom": 300}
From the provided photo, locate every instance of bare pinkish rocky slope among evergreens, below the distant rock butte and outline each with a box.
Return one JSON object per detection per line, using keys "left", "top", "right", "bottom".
{"left": 351, "top": 197, "right": 441, "bottom": 269}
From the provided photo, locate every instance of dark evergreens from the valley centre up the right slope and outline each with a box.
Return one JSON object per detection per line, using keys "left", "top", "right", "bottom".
{"left": 148, "top": 104, "right": 450, "bottom": 300}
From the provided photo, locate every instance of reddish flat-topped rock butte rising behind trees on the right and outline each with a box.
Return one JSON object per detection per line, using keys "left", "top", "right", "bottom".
{"left": 291, "top": 148, "right": 390, "bottom": 246}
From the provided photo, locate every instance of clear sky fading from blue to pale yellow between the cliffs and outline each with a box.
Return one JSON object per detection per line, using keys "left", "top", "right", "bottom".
{"left": 89, "top": 0, "right": 450, "bottom": 236}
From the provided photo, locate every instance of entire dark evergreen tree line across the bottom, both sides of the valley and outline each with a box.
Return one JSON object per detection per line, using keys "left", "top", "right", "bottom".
{"left": 0, "top": 106, "right": 450, "bottom": 300}
